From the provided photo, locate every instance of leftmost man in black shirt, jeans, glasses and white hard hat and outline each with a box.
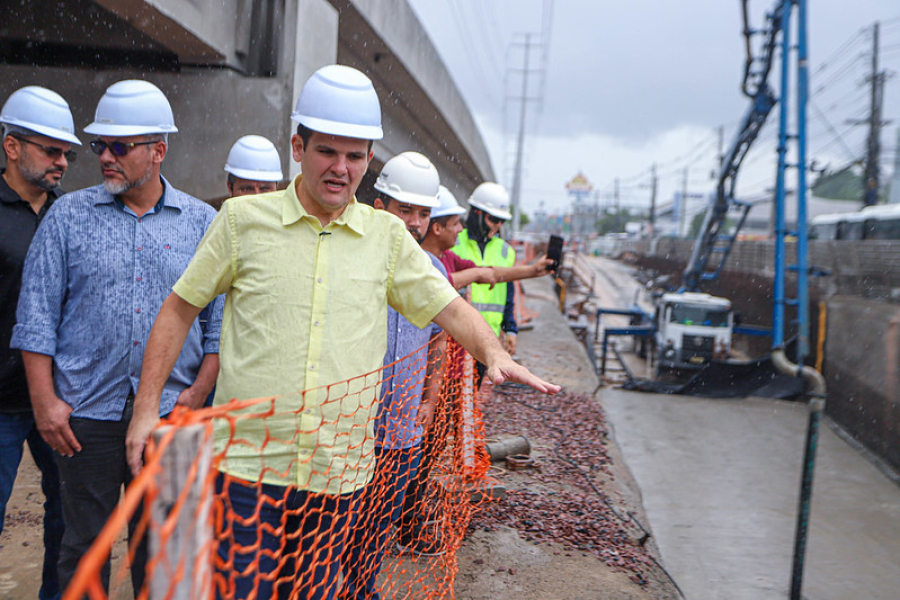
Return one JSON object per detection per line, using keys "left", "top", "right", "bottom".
{"left": 0, "top": 86, "right": 81, "bottom": 600}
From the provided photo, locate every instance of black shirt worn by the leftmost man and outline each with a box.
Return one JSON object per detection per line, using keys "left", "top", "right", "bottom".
{"left": 0, "top": 169, "right": 61, "bottom": 413}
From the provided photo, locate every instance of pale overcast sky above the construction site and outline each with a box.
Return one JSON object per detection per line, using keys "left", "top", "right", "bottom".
{"left": 409, "top": 0, "right": 900, "bottom": 213}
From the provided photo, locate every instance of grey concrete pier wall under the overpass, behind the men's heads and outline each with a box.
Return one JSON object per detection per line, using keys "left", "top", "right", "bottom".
{"left": 0, "top": 0, "right": 338, "bottom": 199}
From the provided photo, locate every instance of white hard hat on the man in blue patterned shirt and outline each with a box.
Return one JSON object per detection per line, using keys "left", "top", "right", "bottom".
{"left": 84, "top": 79, "right": 178, "bottom": 136}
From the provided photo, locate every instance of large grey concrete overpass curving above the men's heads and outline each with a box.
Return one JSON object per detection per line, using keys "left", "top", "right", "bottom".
{"left": 0, "top": 0, "right": 494, "bottom": 200}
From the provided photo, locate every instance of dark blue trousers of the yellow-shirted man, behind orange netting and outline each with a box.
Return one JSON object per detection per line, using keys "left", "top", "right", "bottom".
{"left": 214, "top": 474, "right": 362, "bottom": 600}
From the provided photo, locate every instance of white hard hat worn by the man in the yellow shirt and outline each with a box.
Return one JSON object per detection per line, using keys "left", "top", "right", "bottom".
{"left": 291, "top": 65, "right": 384, "bottom": 140}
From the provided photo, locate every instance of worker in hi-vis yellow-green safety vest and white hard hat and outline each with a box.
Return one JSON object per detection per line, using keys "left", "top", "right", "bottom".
{"left": 451, "top": 182, "right": 519, "bottom": 360}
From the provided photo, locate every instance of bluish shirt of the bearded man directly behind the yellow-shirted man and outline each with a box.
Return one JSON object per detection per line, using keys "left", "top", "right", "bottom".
{"left": 375, "top": 250, "right": 447, "bottom": 450}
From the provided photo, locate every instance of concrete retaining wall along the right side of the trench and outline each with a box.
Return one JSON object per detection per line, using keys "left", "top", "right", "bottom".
{"left": 619, "top": 240, "right": 900, "bottom": 470}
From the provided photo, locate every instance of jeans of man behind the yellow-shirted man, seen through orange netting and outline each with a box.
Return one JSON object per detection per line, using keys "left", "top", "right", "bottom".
{"left": 338, "top": 446, "right": 421, "bottom": 600}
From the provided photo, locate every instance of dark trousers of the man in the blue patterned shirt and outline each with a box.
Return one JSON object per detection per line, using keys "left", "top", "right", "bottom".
{"left": 56, "top": 400, "right": 147, "bottom": 596}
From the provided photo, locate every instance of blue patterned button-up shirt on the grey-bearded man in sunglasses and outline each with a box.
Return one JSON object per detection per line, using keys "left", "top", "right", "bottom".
{"left": 12, "top": 179, "right": 221, "bottom": 421}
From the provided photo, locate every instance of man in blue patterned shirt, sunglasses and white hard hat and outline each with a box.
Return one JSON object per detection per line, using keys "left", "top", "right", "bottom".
{"left": 11, "top": 81, "right": 222, "bottom": 594}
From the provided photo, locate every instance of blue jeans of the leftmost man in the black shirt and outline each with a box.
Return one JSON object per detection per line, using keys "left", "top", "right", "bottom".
{"left": 0, "top": 413, "right": 64, "bottom": 600}
